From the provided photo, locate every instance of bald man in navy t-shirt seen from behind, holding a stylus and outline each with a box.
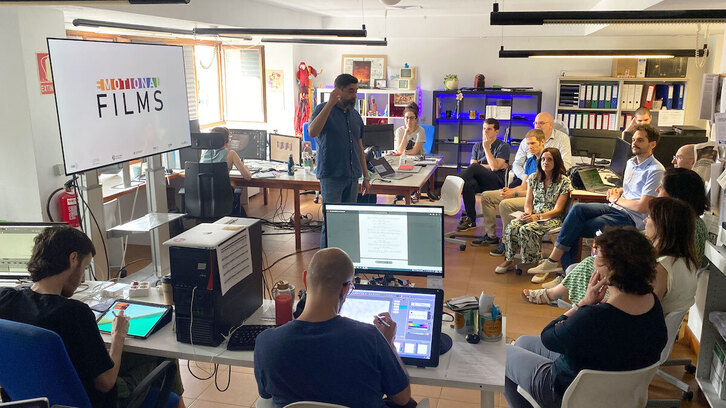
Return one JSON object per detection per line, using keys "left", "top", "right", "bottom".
{"left": 255, "top": 248, "right": 416, "bottom": 408}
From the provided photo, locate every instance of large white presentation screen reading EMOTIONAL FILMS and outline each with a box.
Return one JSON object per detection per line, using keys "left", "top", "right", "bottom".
{"left": 48, "top": 38, "right": 191, "bottom": 174}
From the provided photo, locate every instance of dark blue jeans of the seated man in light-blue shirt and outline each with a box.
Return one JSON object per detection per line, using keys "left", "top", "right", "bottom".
{"left": 555, "top": 203, "right": 635, "bottom": 270}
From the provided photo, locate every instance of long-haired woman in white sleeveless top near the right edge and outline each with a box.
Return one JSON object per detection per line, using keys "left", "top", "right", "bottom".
{"left": 645, "top": 197, "right": 698, "bottom": 315}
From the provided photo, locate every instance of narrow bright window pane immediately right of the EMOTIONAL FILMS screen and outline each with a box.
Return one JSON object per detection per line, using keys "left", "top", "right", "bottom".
{"left": 194, "top": 45, "right": 222, "bottom": 125}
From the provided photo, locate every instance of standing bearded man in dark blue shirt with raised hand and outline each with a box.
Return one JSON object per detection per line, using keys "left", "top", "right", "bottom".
{"left": 308, "top": 74, "right": 370, "bottom": 248}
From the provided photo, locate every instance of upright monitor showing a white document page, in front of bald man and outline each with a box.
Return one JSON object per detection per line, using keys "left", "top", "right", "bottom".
{"left": 323, "top": 204, "right": 444, "bottom": 278}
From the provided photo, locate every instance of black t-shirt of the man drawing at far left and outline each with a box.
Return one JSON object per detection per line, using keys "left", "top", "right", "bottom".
{"left": 0, "top": 288, "right": 116, "bottom": 407}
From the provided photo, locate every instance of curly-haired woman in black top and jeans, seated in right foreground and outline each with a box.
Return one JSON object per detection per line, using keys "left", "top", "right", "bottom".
{"left": 504, "top": 227, "right": 667, "bottom": 408}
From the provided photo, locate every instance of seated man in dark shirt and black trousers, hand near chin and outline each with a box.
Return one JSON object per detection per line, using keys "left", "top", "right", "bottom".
{"left": 456, "top": 118, "right": 509, "bottom": 231}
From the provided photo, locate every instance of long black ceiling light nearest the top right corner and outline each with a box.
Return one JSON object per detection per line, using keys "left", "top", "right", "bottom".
{"left": 490, "top": 3, "right": 726, "bottom": 25}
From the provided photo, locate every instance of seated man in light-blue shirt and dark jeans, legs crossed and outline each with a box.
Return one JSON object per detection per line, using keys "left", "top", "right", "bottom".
{"left": 528, "top": 125, "right": 665, "bottom": 281}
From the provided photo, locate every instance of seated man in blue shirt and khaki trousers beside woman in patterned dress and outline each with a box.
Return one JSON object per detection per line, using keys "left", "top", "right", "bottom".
{"left": 478, "top": 129, "right": 545, "bottom": 252}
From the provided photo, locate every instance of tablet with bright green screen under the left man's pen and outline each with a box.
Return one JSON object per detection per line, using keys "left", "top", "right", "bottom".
{"left": 97, "top": 300, "right": 171, "bottom": 339}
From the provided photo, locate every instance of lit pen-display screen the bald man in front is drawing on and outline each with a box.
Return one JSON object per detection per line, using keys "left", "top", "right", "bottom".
{"left": 340, "top": 285, "right": 444, "bottom": 367}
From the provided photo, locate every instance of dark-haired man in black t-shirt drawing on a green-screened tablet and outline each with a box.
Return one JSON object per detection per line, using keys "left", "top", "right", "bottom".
{"left": 0, "top": 226, "right": 184, "bottom": 407}
